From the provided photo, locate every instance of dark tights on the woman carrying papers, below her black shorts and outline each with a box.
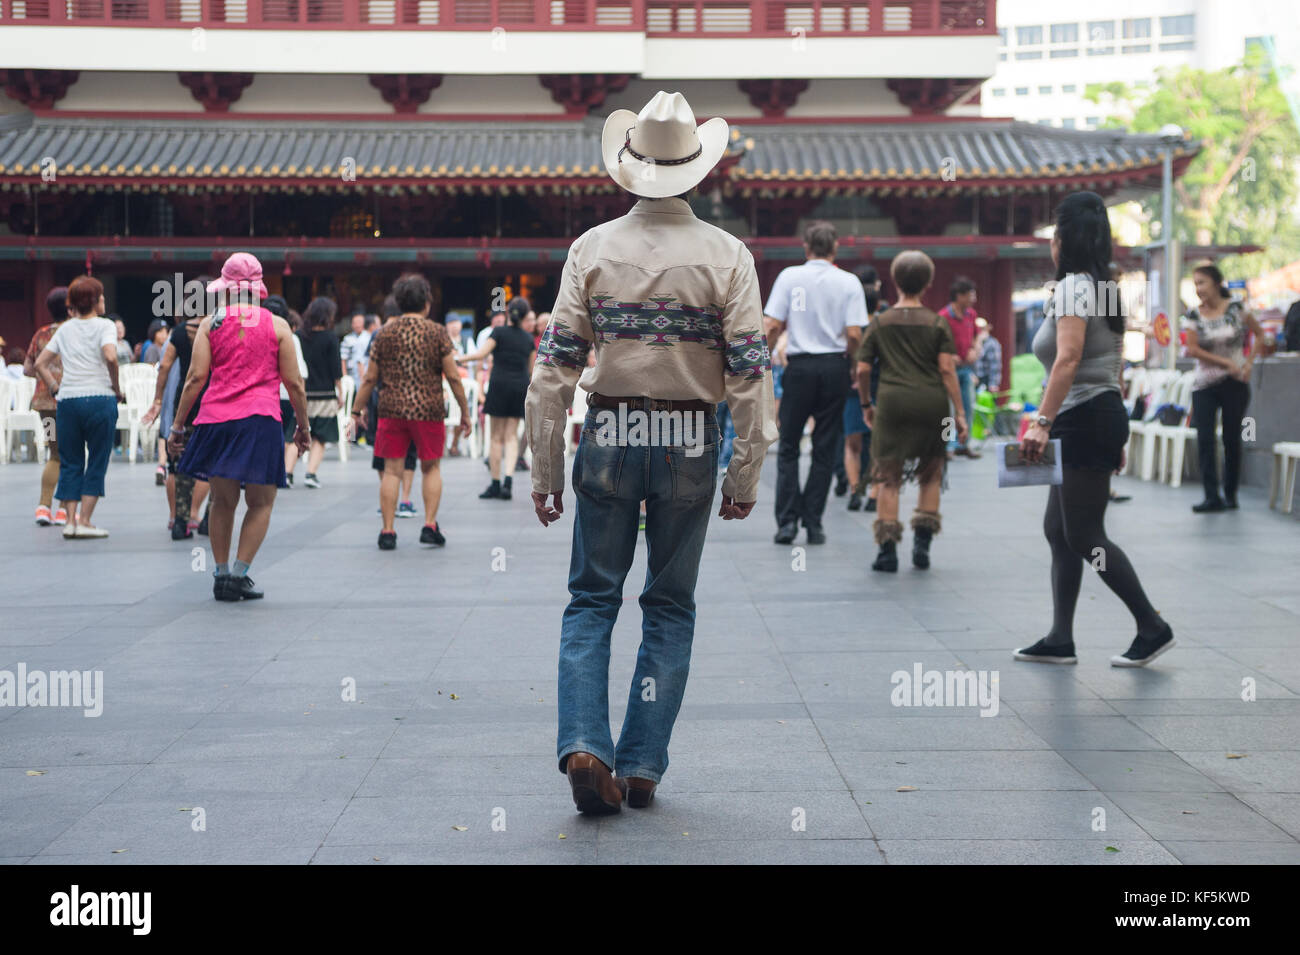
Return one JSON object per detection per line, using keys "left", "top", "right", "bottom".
{"left": 1043, "top": 468, "right": 1164, "bottom": 644}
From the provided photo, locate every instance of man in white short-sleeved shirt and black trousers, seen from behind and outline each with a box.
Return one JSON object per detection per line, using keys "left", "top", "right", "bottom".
{"left": 764, "top": 222, "right": 867, "bottom": 544}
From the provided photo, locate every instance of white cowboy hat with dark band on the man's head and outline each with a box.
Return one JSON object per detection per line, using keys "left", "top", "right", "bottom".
{"left": 601, "top": 90, "right": 729, "bottom": 199}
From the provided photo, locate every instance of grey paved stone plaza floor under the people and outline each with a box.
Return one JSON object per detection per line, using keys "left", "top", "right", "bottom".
{"left": 0, "top": 441, "right": 1300, "bottom": 864}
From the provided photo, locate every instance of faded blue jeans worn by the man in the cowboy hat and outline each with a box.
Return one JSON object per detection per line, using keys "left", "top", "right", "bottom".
{"left": 558, "top": 408, "right": 719, "bottom": 782}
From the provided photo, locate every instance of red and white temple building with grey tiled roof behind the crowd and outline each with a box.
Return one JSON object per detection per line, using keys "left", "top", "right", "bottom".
{"left": 0, "top": 0, "right": 1197, "bottom": 384}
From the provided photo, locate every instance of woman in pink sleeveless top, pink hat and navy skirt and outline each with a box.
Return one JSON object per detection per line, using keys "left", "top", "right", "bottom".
{"left": 168, "top": 252, "right": 311, "bottom": 600}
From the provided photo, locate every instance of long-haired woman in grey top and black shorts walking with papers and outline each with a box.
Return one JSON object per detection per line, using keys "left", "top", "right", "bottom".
{"left": 1015, "top": 192, "right": 1174, "bottom": 667}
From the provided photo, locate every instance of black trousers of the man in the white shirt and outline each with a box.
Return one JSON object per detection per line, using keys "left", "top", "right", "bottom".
{"left": 776, "top": 352, "right": 849, "bottom": 528}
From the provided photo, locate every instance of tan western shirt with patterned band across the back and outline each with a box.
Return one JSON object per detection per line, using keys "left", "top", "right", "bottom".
{"left": 527, "top": 199, "right": 777, "bottom": 503}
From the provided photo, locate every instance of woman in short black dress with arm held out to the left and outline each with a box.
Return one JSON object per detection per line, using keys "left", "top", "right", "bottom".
{"left": 456, "top": 298, "right": 537, "bottom": 500}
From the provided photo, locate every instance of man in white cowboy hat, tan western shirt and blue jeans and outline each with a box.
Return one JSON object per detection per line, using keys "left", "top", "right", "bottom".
{"left": 527, "top": 92, "right": 776, "bottom": 813}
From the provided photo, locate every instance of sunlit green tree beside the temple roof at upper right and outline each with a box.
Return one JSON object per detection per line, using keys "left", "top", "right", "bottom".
{"left": 1087, "top": 53, "right": 1300, "bottom": 272}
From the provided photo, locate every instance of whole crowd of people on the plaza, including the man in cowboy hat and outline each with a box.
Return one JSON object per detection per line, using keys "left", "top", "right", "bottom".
{"left": 12, "top": 92, "right": 1279, "bottom": 812}
